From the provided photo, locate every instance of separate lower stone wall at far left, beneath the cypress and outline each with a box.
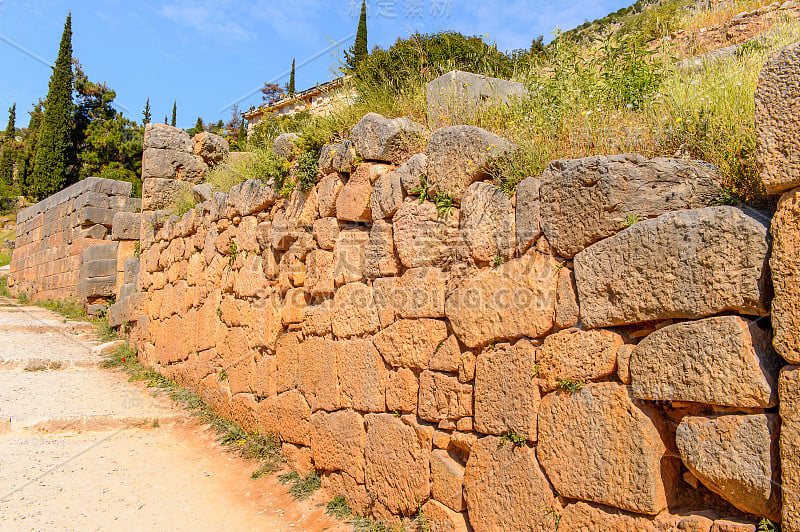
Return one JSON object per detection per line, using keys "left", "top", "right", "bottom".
{"left": 8, "top": 177, "right": 141, "bottom": 302}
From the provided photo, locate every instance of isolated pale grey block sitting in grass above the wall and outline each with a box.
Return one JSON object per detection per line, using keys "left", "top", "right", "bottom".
{"left": 425, "top": 70, "right": 528, "bottom": 123}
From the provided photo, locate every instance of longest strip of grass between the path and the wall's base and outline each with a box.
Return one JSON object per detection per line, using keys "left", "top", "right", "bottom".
{"left": 102, "top": 343, "right": 284, "bottom": 480}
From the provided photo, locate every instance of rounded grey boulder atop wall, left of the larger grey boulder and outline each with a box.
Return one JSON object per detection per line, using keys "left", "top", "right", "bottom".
{"left": 350, "top": 113, "right": 424, "bottom": 164}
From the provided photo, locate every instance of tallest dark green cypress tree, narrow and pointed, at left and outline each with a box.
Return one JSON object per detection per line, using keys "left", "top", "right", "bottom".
{"left": 33, "top": 14, "right": 72, "bottom": 199}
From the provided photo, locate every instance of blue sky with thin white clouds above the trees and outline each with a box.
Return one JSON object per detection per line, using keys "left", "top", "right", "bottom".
{"left": 0, "top": 0, "right": 632, "bottom": 128}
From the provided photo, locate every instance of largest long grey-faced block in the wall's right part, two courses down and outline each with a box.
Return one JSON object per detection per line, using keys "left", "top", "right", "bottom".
{"left": 575, "top": 207, "right": 772, "bottom": 328}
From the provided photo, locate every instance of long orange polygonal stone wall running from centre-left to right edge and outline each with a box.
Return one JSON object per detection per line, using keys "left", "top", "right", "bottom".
{"left": 9, "top": 41, "right": 800, "bottom": 532}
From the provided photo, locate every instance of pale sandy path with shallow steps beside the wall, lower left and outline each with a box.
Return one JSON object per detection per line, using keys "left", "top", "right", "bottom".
{"left": 0, "top": 299, "right": 349, "bottom": 531}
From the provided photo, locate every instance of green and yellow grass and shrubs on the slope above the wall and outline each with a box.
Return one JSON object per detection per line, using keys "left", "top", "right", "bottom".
{"left": 234, "top": 0, "right": 800, "bottom": 205}
